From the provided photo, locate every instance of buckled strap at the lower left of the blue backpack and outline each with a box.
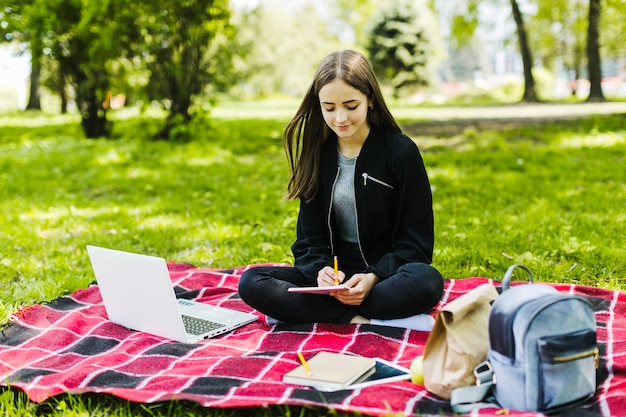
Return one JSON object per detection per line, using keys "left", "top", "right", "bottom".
{"left": 450, "top": 361, "right": 500, "bottom": 414}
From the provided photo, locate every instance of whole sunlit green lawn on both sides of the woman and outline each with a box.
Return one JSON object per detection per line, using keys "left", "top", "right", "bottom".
{"left": 0, "top": 106, "right": 626, "bottom": 416}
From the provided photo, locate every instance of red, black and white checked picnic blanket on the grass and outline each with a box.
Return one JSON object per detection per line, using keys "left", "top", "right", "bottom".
{"left": 0, "top": 263, "right": 626, "bottom": 416}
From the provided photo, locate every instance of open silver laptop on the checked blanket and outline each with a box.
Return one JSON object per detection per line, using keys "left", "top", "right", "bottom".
{"left": 87, "top": 245, "right": 257, "bottom": 343}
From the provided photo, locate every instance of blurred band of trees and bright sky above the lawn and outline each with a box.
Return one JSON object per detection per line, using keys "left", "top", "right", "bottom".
{"left": 0, "top": 0, "right": 626, "bottom": 120}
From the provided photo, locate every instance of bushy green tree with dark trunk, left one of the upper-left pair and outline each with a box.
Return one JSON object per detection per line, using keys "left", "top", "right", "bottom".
{"left": 13, "top": 0, "right": 134, "bottom": 138}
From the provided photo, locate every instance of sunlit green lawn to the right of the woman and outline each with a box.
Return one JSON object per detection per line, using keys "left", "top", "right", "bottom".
{"left": 425, "top": 116, "right": 626, "bottom": 288}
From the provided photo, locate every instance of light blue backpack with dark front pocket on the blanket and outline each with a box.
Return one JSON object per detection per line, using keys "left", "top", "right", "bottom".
{"left": 451, "top": 265, "right": 598, "bottom": 413}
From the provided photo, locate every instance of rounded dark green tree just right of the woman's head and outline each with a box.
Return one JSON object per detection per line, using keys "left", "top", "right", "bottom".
{"left": 367, "top": 0, "right": 439, "bottom": 96}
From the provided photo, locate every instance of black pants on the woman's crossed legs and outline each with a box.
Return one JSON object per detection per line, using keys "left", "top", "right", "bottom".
{"left": 239, "top": 262, "right": 443, "bottom": 323}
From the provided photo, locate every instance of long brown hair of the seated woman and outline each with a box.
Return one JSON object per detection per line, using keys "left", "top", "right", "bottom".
{"left": 283, "top": 49, "right": 401, "bottom": 201}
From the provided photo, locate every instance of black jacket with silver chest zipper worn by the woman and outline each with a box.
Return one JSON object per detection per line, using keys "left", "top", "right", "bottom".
{"left": 291, "top": 128, "right": 434, "bottom": 284}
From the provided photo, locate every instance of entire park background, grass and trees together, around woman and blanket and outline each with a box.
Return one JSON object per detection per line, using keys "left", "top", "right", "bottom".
{"left": 0, "top": 0, "right": 626, "bottom": 415}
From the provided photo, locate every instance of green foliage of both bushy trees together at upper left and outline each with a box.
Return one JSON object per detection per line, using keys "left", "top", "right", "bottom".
{"left": 0, "top": 0, "right": 234, "bottom": 138}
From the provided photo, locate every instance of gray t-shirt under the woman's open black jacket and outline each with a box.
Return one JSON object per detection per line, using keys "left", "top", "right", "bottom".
{"left": 333, "top": 152, "right": 358, "bottom": 243}
